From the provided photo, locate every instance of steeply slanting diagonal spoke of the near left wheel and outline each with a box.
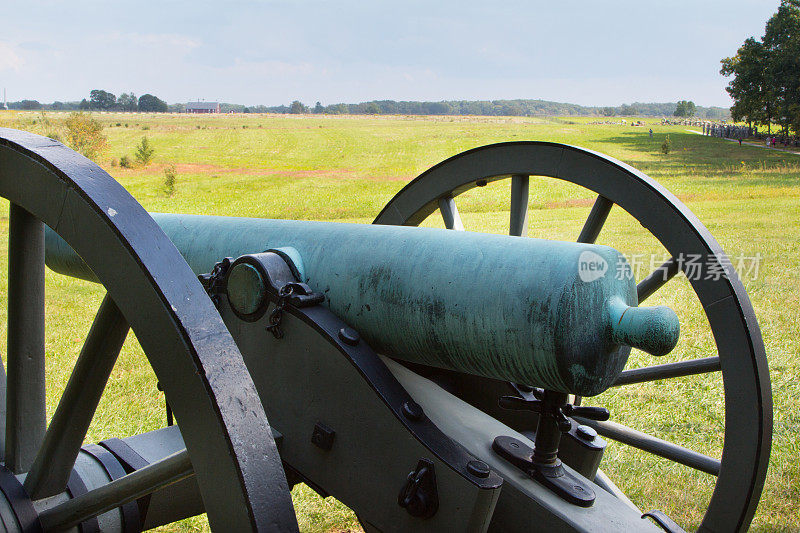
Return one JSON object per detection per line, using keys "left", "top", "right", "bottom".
{"left": 25, "top": 295, "right": 130, "bottom": 500}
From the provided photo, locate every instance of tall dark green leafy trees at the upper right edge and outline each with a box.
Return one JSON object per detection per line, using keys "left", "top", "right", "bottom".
{"left": 720, "top": 0, "right": 800, "bottom": 135}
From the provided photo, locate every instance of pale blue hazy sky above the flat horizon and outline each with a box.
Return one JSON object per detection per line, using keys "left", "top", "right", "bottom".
{"left": 0, "top": 0, "right": 780, "bottom": 107}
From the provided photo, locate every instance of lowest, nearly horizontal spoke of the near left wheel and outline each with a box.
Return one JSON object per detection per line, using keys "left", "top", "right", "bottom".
{"left": 39, "top": 449, "right": 194, "bottom": 531}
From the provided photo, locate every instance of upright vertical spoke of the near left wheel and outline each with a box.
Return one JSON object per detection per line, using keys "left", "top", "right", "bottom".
{"left": 5, "top": 204, "right": 47, "bottom": 474}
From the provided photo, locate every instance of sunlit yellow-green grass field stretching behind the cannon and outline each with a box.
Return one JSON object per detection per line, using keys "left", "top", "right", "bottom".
{"left": 0, "top": 112, "right": 800, "bottom": 531}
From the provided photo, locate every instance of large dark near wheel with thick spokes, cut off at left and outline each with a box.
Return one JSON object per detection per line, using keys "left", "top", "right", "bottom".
{"left": 0, "top": 128, "right": 297, "bottom": 531}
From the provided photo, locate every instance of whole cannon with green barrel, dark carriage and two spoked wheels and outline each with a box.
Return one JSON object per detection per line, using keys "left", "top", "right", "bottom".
{"left": 0, "top": 129, "right": 772, "bottom": 532}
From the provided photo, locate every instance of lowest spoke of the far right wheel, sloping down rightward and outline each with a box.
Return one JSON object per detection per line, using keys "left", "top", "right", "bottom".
{"left": 575, "top": 417, "right": 720, "bottom": 476}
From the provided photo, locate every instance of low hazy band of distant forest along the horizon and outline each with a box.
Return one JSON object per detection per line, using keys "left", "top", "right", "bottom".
{"left": 8, "top": 97, "right": 731, "bottom": 120}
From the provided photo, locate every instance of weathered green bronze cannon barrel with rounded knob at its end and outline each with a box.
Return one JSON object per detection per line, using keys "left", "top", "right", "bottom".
{"left": 46, "top": 214, "right": 679, "bottom": 396}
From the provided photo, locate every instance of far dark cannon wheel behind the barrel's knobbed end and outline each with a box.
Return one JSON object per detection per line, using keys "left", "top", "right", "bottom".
{"left": 374, "top": 142, "right": 772, "bottom": 531}
